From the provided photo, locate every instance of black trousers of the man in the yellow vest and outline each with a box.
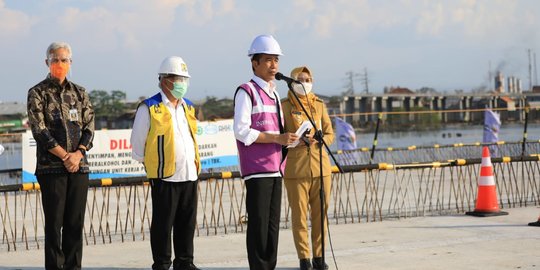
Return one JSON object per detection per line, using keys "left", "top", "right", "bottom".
{"left": 150, "top": 179, "right": 198, "bottom": 269}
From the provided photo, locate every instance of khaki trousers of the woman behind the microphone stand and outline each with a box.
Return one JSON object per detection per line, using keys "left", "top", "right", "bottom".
{"left": 284, "top": 176, "right": 332, "bottom": 259}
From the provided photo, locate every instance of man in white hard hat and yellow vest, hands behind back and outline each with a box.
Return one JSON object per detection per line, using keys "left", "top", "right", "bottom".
{"left": 131, "top": 56, "right": 201, "bottom": 270}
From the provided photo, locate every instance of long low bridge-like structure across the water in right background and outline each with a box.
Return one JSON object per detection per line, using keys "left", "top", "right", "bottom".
{"left": 338, "top": 93, "right": 540, "bottom": 127}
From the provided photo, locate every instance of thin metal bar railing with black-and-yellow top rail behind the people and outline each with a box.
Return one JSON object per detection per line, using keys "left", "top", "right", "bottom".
{"left": 0, "top": 155, "right": 540, "bottom": 251}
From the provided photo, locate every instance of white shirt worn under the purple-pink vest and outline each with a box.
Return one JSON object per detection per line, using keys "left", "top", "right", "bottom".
{"left": 233, "top": 76, "right": 283, "bottom": 180}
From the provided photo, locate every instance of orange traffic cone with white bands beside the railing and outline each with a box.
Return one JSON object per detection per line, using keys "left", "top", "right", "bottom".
{"left": 466, "top": 146, "right": 508, "bottom": 217}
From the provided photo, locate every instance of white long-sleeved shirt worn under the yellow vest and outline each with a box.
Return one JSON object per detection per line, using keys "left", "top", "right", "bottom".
{"left": 131, "top": 92, "right": 198, "bottom": 182}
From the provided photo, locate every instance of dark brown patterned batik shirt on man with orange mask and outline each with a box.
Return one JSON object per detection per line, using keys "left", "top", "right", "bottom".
{"left": 28, "top": 75, "right": 94, "bottom": 175}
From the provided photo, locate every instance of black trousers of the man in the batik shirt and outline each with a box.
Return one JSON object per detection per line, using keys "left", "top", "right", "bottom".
{"left": 37, "top": 173, "right": 88, "bottom": 269}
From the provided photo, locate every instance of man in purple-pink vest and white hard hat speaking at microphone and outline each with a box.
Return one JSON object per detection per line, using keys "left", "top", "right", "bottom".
{"left": 234, "top": 35, "right": 298, "bottom": 270}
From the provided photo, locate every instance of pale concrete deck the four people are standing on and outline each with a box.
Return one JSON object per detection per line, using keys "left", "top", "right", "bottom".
{"left": 0, "top": 206, "right": 540, "bottom": 270}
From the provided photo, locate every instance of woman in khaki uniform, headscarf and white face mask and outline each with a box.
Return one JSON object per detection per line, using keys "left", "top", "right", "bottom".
{"left": 282, "top": 66, "right": 334, "bottom": 269}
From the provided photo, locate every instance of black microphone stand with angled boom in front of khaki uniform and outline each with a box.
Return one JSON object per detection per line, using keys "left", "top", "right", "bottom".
{"left": 287, "top": 82, "right": 343, "bottom": 268}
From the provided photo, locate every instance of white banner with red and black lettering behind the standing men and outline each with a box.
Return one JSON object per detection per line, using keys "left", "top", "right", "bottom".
{"left": 22, "top": 119, "right": 238, "bottom": 183}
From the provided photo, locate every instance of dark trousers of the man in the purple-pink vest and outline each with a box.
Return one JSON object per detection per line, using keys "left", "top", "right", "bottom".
{"left": 246, "top": 177, "right": 282, "bottom": 270}
